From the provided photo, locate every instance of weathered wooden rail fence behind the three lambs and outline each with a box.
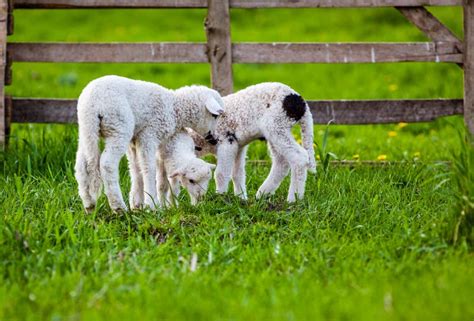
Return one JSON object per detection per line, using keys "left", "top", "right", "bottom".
{"left": 0, "top": 0, "right": 474, "bottom": 144}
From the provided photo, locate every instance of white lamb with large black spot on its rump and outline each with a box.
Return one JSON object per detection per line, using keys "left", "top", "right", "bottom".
{"left": 188, "top": 83, "right": 316, "bottom": 202}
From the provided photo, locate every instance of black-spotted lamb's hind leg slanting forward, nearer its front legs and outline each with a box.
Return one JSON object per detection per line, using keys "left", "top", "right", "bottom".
{"left": 257, "top": 142, "right": 290, "bottom": 198}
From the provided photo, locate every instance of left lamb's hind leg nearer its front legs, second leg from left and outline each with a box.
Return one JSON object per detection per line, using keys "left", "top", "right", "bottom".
{"left": 100, "top": 137, "right": 130, "bottom": 211}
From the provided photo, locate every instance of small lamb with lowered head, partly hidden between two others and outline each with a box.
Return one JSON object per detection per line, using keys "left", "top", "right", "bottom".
{"left": 156, "top": 132, "right": 216, "bottom": 205}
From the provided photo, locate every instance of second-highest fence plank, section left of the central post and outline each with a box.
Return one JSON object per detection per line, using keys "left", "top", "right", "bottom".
{"left": 8, "top": 42, "right": 208, "bottom": 63}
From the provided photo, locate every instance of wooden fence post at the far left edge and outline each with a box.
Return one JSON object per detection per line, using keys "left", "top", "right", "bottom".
{"left": 0, "top": 0, "right": 8, "bottom": 148}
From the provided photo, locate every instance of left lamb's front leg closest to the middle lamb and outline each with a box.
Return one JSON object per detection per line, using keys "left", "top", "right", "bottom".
{"left": 137, "top": 136, "right": 158, "bottom": 210}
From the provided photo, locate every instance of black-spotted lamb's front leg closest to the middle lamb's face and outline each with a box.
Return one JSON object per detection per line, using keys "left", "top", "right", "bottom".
{"left": 214, "top": 141, "right": 239, "bottom": 194}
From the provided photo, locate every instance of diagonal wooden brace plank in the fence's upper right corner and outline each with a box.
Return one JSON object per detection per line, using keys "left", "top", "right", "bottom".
{"left": 396, "top": 7, "right": 462, "bottom": 48}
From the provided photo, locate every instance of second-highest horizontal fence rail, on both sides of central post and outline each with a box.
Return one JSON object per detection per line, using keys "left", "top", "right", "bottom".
{"left": 8, "top": 42, "right": 462, "bottom": 64}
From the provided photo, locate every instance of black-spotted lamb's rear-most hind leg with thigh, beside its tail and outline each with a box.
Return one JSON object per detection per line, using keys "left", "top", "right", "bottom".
{"left": 266, "top": 128, "right": 309, "bottom": 203}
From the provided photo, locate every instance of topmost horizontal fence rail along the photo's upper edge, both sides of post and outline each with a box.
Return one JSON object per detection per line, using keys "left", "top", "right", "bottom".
{"left": 15, "top": 0, "right": 462, "bottom": 9}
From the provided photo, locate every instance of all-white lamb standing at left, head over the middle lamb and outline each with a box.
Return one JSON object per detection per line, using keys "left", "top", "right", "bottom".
{"left": 75, "top": 76, "right": 223, "bottom": 211}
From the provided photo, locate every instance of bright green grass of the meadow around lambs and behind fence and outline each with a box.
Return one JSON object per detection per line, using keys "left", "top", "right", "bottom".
{"left": 0, "top": 8, "right": 474, "bottom": 320}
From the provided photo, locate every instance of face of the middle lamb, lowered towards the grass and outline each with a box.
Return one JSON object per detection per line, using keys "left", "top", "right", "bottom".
{"left": 170, "top": 158, "right": 216, "bottom": 205}
